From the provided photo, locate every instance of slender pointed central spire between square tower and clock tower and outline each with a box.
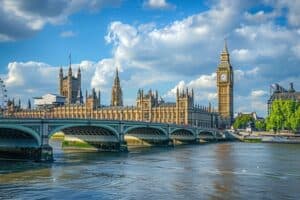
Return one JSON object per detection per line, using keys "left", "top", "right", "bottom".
{"left": 111, "top": 68, "right": 123, "bottom": 106}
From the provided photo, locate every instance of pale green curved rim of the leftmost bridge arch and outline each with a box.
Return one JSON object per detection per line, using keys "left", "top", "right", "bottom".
{"left": 0, "top": 124, "right": 42, "bottom": 147}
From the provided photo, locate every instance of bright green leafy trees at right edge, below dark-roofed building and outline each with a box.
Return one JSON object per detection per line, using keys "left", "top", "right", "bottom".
{"left": 266, "top": 100, "right": 300, "bottom": 132}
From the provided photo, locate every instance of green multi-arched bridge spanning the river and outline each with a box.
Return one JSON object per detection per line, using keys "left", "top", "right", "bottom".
{"left": 0, "top": 118, "right": 234, "bottom": 161}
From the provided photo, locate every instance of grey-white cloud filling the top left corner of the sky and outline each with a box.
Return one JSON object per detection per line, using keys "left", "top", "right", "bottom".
{"left": 0, "top": 0, "right": 121, "bottom": 42}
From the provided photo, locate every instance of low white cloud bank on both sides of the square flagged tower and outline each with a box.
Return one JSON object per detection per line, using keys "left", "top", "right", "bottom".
{"left": 4, "top": 60, "right": 115, "bottom": 102}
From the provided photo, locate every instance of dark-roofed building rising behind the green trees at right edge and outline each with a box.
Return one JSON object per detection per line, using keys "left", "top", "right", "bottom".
{"left": 268, "top": 83, "right": 300, "bottom": 115}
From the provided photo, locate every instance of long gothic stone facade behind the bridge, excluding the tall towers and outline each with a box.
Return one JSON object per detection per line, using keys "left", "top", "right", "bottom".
{"left": 12, "top": 90, "right": 218, "bottom": 128}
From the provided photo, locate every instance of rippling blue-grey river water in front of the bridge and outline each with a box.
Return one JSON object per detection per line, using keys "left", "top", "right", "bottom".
{"left": 0, "top": 141, "right": 300, "bottom": 199}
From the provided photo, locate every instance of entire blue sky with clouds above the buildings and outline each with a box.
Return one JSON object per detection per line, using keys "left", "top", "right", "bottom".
{"left": 0, "top": 0, "right": 300, "bottom": 116}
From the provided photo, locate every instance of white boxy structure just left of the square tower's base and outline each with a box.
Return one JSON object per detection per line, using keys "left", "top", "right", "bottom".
{"left": 33, "top": 94, "right": 66, "bottom": 108}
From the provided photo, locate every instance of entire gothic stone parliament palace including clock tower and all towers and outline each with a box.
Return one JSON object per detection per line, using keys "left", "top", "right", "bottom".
{"left": 6, "top": 42, "right": 233, "bottom": 128}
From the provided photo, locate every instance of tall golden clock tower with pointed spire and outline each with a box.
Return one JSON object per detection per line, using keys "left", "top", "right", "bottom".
{"left": 217, "top": 40, "right": 233, "bottom": 125}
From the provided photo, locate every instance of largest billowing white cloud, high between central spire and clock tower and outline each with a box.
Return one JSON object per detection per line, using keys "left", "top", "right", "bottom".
{"left": 105, "top": 3, "right": 241, "bottom": 75}
